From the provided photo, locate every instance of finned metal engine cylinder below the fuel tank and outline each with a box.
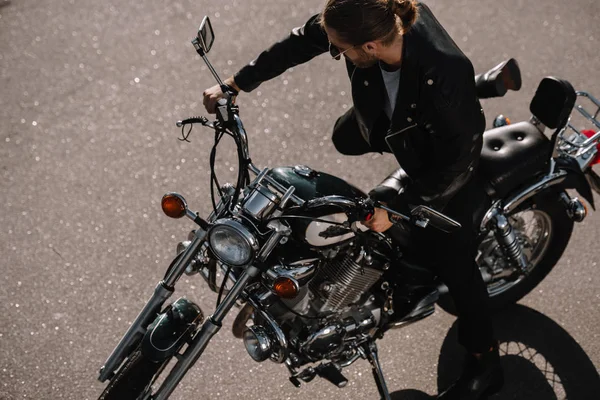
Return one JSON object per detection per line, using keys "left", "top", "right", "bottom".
{"left": 310, "top": 256, "right": 383, "bottom": 312}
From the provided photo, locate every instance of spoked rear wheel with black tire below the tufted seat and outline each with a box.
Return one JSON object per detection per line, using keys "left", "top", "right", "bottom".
{"left": 438, "top": 192, "right": 573, "bottom": 315}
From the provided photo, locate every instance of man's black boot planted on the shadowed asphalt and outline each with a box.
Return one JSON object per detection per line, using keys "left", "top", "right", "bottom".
{"left": 438, "top": 346, "right": 504, "bottom": 400}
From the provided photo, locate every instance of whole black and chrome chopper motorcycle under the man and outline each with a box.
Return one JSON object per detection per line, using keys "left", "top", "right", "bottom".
{"left": 99, "top": 17, "right": 600, "bottom": 400}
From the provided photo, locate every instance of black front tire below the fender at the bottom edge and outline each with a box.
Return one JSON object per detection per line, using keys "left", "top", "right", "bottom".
{"left": 98, "top": 347, "right": 168, "bottom": 400}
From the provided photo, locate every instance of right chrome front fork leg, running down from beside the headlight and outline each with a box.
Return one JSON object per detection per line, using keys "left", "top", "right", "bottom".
{"left": 152, "top": 266, "right": 260, "bottom": 400}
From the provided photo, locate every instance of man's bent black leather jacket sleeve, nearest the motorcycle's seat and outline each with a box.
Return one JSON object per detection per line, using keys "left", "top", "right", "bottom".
{"left": 407, "top": 60, "right": 485, "bottom": 210}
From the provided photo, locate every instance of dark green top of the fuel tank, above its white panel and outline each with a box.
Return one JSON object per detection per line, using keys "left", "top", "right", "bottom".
{"left": 268, "top": 166, "right": 367, "bottom": 201}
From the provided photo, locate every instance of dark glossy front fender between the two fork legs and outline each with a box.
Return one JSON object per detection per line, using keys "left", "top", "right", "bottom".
{"left": 142, "top": 297, "right": 204, "bottom": 362}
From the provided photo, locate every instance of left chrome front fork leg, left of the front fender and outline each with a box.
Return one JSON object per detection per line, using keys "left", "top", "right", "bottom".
{"left": 98, "top": 229, "right": 206, "bottom": 382}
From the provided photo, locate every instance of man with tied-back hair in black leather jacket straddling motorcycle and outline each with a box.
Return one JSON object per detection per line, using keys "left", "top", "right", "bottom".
{"left": 204, "top": 0, "right": 503, "bottom": 399}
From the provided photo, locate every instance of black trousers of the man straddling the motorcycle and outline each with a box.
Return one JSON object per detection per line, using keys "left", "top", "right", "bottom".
{"left": 332, "top": 118, "right": 494, "bottom": 353}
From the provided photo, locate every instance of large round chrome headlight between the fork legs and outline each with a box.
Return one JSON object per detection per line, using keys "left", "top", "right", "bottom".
{"left": 208, "top": 219, "right": 258, "bottom": 267}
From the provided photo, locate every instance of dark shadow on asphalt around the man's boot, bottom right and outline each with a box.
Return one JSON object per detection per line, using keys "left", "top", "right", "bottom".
{"left": 392, "top": 305, "right": 600, "bottom": 400}
